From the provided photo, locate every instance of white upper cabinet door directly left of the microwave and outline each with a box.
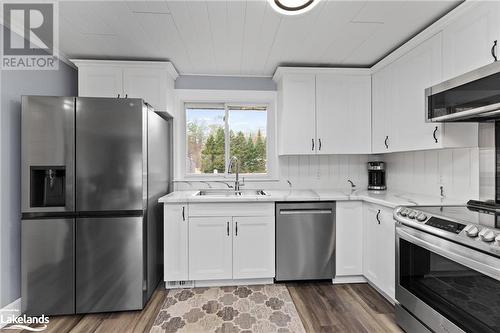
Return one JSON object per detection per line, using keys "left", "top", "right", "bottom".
{"left": 389, "top": 33, "right": 442, "bottom": 151}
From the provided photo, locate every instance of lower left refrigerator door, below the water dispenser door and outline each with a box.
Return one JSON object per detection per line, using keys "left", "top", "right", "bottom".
{"left": 21, "top": 219, "right": 75, "bottom": 316}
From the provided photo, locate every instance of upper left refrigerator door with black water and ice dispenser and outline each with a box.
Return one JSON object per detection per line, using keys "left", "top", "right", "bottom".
{"left": 21, "top": 96, "right": 75, "bottom": 213}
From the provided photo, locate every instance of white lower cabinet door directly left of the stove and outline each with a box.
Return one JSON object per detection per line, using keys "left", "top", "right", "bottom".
{"left": 363, "top": 204, "right": 396, "bottom": 299}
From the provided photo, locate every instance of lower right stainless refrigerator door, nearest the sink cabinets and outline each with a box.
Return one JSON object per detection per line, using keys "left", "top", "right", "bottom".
{"left": 76, "top": 217, "right": 143, "bottom": 313}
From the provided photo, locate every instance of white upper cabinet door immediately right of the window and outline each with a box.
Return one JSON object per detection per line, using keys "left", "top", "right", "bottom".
{"left": 278, "top": 74, "right": 317, "bottom": 155}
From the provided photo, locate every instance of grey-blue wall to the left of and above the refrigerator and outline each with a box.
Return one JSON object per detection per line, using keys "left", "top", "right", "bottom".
{"left": 0, "top": 29, "right": 78, "bottom": 308}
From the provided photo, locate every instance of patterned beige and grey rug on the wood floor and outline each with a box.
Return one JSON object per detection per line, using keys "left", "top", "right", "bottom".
{"left": 150, "top": 285, "right": 305, "bottom": 333}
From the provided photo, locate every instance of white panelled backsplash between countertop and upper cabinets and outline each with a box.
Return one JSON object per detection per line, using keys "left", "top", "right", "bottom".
{"left": 175, "top": 148, "right": 479, "bottom": 201}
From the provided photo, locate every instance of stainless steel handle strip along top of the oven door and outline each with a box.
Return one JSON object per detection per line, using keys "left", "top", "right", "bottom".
{"left": 396, "top": 225, "right": 500, "bottom": 281}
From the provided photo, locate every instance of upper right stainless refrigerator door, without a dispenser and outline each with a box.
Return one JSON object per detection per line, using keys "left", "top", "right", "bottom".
{"left": 76, "top": 98, "right": 146, "bottom": 212}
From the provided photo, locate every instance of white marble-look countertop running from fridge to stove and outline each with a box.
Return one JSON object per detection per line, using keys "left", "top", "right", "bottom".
{"left": 158, "top": 189, "right": 465, "bottom": 208}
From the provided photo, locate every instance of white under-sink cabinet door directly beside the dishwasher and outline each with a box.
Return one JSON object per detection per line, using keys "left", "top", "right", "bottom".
{"left": 233, "top": 216, "right": 275, "bottom": 279}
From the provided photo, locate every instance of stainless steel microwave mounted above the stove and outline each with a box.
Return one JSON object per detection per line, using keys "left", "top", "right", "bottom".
{"left": 425, "top": 61, "right": 500, "bottom": 122}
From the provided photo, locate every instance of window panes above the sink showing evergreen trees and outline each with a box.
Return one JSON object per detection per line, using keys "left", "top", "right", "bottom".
{"left": 185, "top": 103, "right": 268, "bottom": 175}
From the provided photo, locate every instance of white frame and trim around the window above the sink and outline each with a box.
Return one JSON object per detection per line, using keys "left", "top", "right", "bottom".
{"left": 174, "top": 89, "right": 278, "bottom": 182}
